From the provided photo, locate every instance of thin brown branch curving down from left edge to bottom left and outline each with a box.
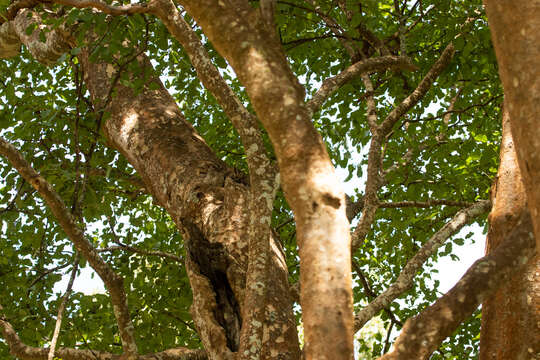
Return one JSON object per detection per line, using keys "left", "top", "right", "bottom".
{"left": 0, "top": 137, "right": 137, "bottom": 355}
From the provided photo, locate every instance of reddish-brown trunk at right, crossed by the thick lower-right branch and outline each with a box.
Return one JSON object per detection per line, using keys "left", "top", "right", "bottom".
{"left": 480, "top": 107, "right": 540, "bottom": 360}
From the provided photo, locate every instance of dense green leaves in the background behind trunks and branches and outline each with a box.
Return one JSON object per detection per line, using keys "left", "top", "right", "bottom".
{"left": 0, "top": 0, "right": 502, "bottom": 359}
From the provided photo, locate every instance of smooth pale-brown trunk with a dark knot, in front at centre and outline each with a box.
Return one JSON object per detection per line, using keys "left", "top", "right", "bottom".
{"left": 177, "top": 0, "right": 353, "bottom": 360}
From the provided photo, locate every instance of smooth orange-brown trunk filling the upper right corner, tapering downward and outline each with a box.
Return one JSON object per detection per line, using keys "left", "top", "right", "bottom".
{"left": 484, "top": 0, "right": 540, "bottom": 249}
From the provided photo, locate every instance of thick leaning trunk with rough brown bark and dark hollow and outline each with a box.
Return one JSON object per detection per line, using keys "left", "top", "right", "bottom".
{"left": 81, "top": 48, "right": 299, "bottom": 359}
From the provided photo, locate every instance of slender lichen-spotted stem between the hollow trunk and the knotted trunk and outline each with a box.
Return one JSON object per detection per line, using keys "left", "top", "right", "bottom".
{"left": 143, "top": 0, "right": 277, "bottom": 358}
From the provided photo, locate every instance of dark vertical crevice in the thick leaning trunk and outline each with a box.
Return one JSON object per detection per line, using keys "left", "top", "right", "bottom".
{"left": 182, "top": 220, "right": 242, "bottom": 352}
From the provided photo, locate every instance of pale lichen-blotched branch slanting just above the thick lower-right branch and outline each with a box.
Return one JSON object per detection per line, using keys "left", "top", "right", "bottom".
{"left": 354, "top": 200, "right": 491, "bottom": 331}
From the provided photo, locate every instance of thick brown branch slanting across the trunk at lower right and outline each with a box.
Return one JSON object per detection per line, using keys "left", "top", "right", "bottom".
{"left": 380, "top": 211, "right": 536, "bottom": 360}
